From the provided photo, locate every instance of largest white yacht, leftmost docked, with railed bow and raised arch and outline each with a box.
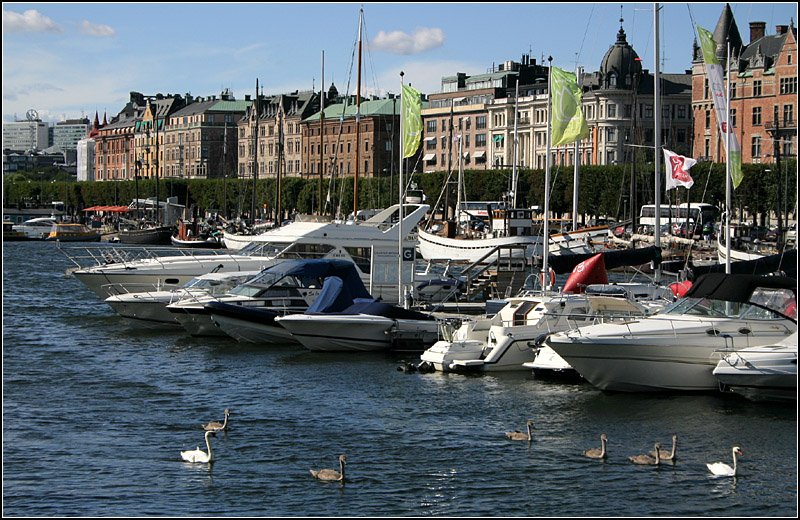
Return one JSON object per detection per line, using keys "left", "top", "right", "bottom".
{"left": 61, "top": 204, "right": 430, "bottom": 301}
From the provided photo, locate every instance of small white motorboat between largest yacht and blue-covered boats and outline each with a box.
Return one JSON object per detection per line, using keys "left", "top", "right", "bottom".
{"left": 105, "top": 271, "right": 259, "bottom": 327}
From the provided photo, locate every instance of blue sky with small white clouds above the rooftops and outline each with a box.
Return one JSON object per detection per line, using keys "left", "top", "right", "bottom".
{"left": 2, "top": 2, "right": 797, "bottom": 122}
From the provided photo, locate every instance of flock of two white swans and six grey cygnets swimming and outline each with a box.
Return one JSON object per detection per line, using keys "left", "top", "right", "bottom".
{"left": 181, "top": 408, "right": 743, "bottom": 482}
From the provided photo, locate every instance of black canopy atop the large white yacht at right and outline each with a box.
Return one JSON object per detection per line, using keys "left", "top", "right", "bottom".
{"left": 686, "top": 273, "right": 797, "bottom": 303}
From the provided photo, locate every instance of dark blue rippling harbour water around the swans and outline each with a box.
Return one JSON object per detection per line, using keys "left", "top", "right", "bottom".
{"left": 3, "top": 242, "right": 797, "bottom": 517}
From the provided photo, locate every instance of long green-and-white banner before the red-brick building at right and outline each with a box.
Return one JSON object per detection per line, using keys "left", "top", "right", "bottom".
{"left": 697, "top": 26, "right": 744, "bottom": 189}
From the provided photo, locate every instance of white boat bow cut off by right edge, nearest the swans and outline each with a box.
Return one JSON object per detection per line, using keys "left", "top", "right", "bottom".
{"left": 713, "top": 332, "right": 797, "bottom": 401}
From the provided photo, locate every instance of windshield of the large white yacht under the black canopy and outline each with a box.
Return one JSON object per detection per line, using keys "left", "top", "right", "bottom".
{"left": 662, "top": 288, "right": 797, "bottom": 320}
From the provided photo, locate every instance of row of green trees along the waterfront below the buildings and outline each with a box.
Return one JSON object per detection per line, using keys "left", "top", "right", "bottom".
{"left": 3, "top": 159, "right": 797, "bottom": 225}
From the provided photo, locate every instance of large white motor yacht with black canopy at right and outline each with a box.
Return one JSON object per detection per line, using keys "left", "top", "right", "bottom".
{"left": 546, "top": 273, "right": 797, "bottom": 392}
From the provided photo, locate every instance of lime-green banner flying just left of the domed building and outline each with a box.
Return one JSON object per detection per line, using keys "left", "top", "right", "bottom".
{"left": 550, "top": 67, "right": 589, "bottom": 146}
